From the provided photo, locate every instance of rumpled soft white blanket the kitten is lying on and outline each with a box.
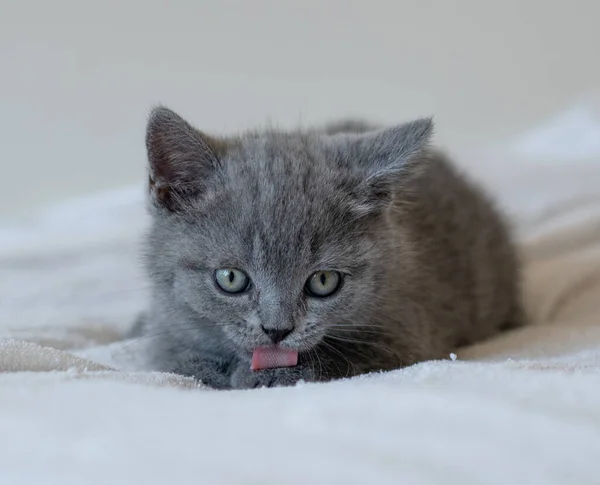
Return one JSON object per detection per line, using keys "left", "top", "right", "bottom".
{"left": 0, "top": 100, "right": 600, "bottom": 485}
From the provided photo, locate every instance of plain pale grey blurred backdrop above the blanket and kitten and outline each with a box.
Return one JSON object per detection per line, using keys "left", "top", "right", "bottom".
{"left": 0, "top": 0, "right": 600, "bottom": 216}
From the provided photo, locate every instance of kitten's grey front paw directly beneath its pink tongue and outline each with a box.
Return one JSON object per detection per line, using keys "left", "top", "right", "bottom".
{"left": 231, "top": 365, "right": 314, "bottom": 389}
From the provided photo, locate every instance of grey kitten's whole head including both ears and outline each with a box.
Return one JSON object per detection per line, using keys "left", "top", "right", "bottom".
{"left": 147, "top": 108, "right": 432, "bottom": 352}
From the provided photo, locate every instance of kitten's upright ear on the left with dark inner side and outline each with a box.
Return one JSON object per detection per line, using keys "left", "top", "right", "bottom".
{"left": 146, "top": 106, "right": 219, "bottom": 211}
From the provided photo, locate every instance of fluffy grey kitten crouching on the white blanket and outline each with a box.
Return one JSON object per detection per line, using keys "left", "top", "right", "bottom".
{"left": 135, "top": 108, "right": 523, "bottom": 389}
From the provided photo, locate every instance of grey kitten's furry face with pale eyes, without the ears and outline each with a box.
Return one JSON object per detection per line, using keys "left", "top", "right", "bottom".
{"left": 153, "top": 136, "right": 390, "bottom": 351}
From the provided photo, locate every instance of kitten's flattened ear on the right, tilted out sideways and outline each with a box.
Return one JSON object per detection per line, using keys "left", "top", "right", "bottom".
{"left": 346, "top": 118, "right": 433, "bottom": 209}
